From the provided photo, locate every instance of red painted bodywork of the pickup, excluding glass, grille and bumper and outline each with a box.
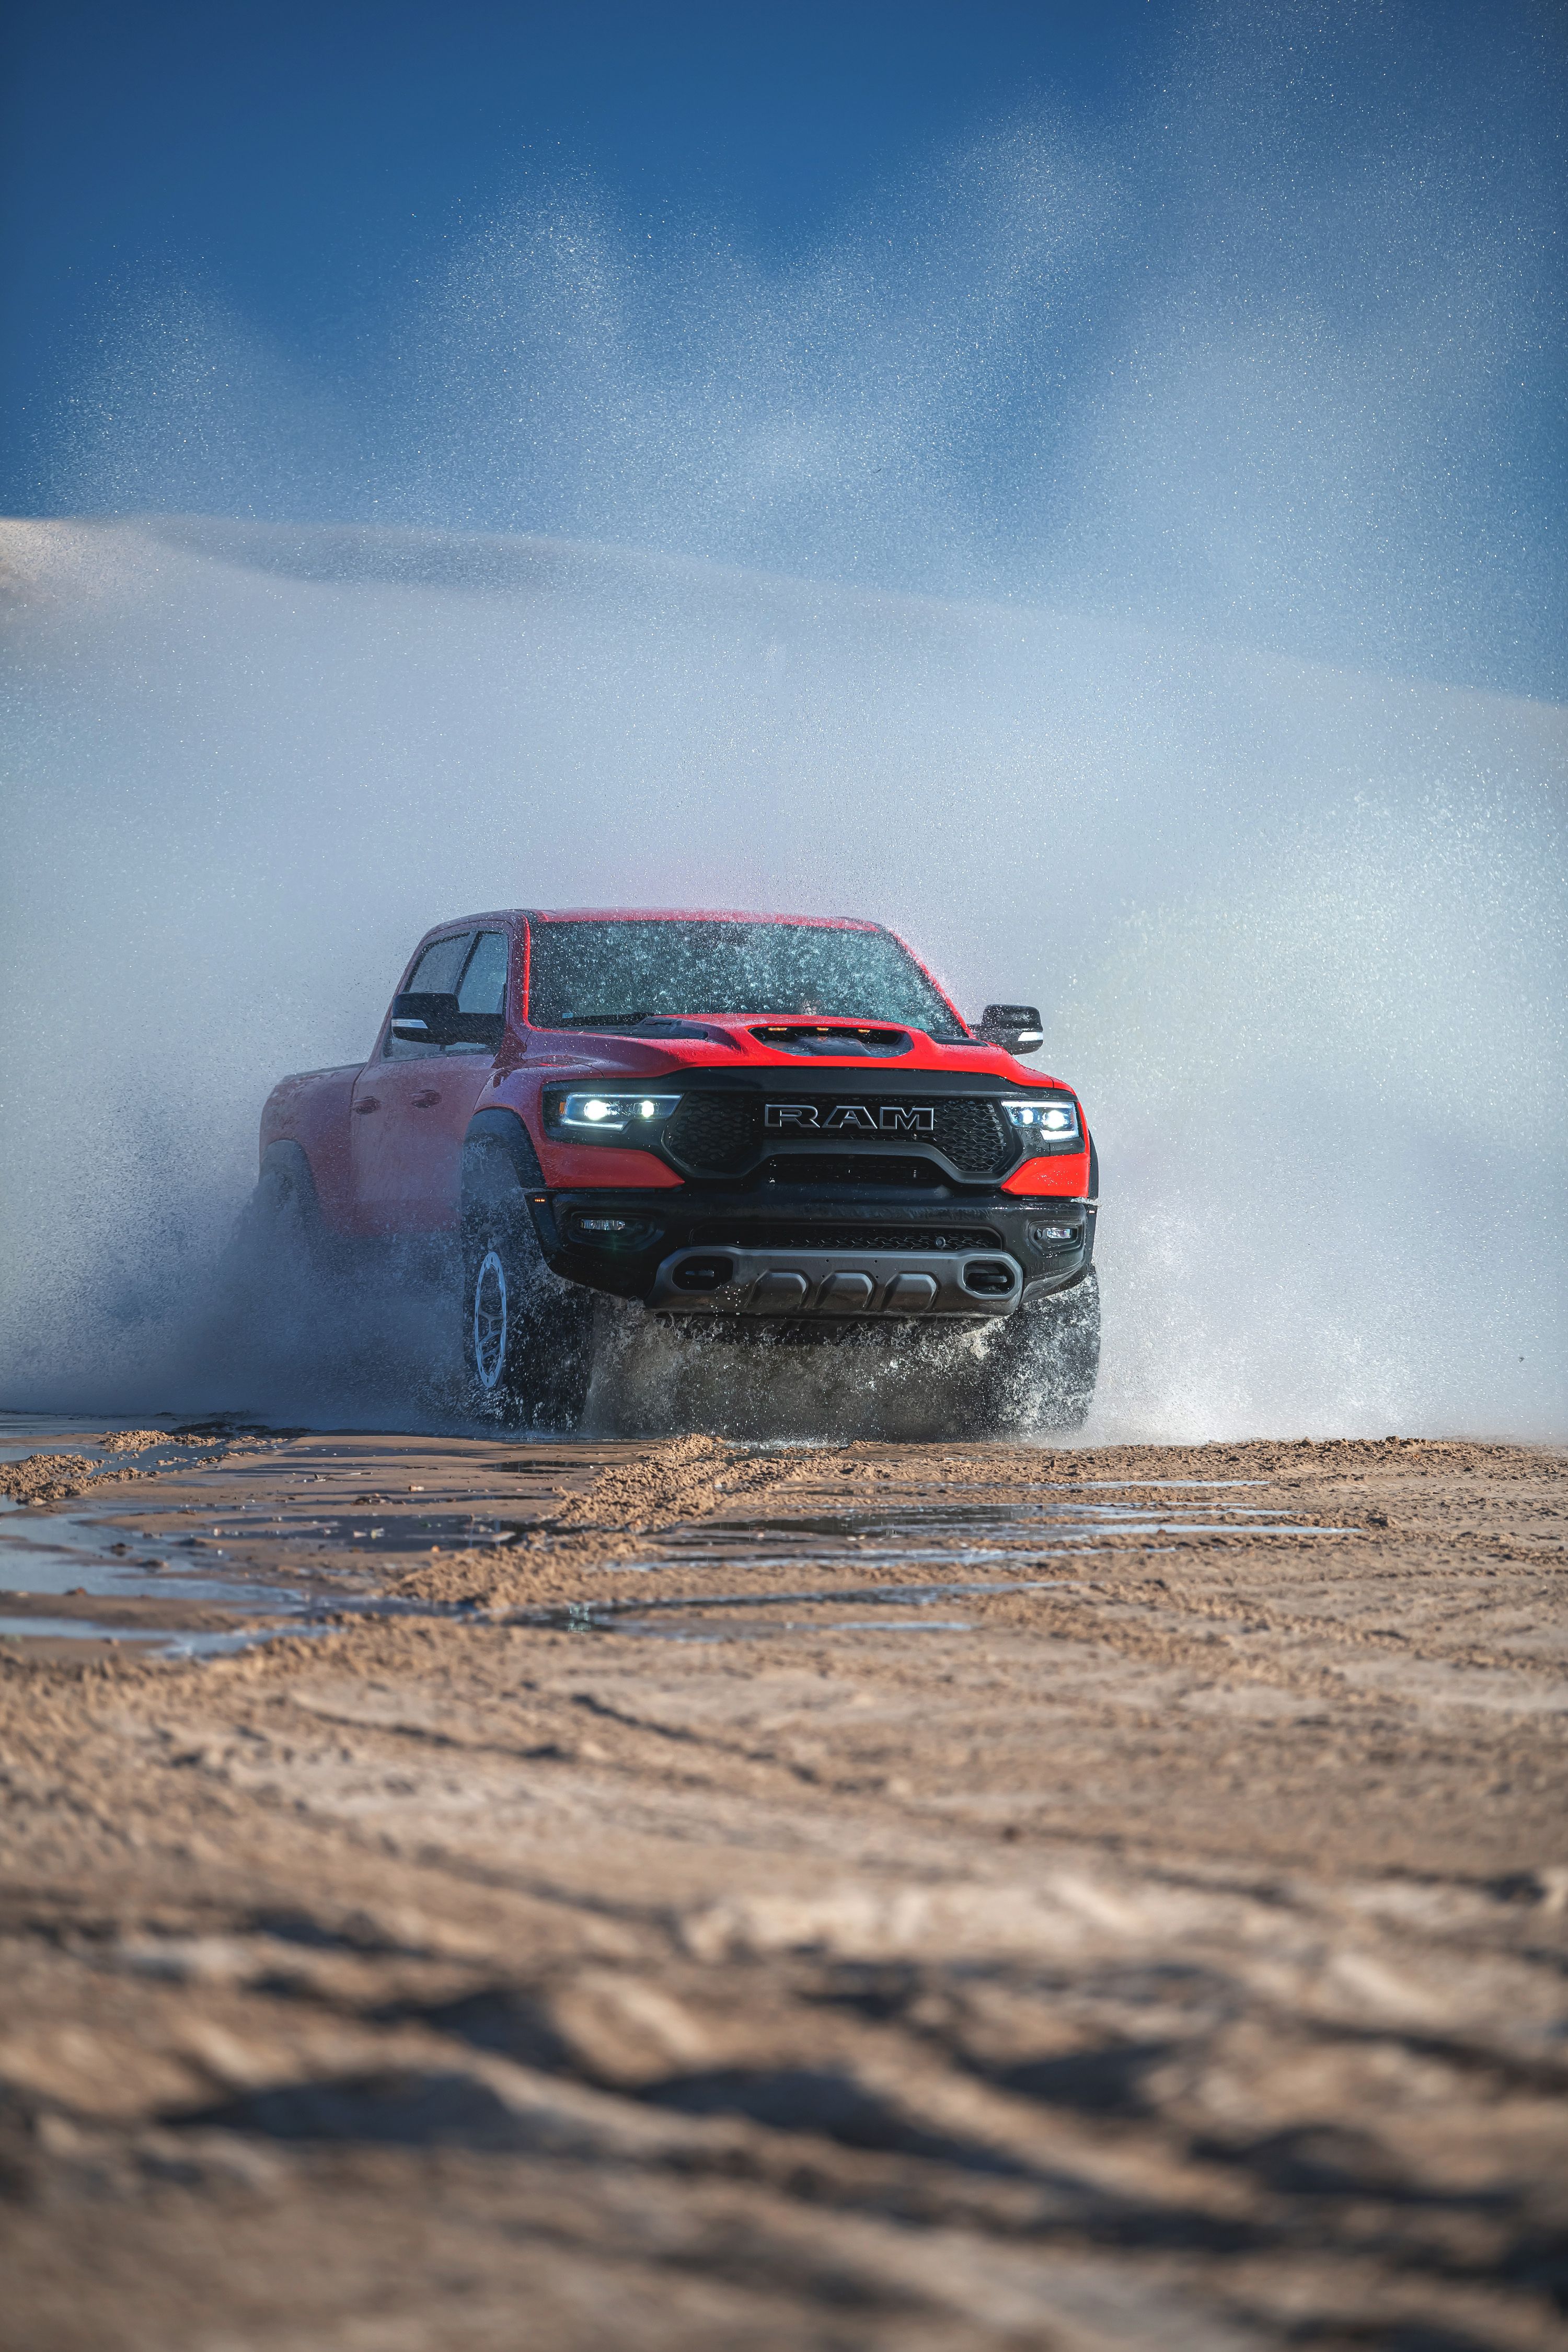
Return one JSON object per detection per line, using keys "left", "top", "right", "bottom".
{"left": 261, "top": 908, "right": 1088, "bottom": 1235}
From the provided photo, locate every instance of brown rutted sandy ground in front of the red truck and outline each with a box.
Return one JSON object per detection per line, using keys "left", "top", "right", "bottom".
{"left": 0, "top": 1433, "right": 1568, "bottom": 2352}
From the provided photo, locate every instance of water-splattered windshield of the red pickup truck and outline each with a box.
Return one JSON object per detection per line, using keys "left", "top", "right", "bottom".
{"left": 529, "top": 922, "right": 966, "bottom": 1040}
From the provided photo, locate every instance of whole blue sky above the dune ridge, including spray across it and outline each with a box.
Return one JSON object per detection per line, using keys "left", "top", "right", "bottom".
{"left": 0, "top": 0, "right": 1568, "bottom": 694}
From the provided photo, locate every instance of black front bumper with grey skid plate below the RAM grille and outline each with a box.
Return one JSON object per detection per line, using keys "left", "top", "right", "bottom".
{"left": 529, "top": 1183, "right": 1098, "bottom": 1315}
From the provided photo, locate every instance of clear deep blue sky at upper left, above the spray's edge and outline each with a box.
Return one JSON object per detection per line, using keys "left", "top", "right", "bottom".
{"left": 0, "top": 0, "right": 1171, "bottom": 511}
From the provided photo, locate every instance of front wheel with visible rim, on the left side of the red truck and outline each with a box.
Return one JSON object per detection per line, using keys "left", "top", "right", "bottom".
{"left": 463, "top": 1141, "right": 595, "bottom": 1430}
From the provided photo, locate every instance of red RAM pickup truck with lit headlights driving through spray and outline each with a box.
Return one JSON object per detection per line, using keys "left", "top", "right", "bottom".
{"left": 259, "top": 910, "right": 1100, "bottom": 1435}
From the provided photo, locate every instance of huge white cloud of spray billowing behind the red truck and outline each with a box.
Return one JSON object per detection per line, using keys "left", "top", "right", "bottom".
{"left": 0, "top": 9, "right": 1568, "bottom": 1437}
